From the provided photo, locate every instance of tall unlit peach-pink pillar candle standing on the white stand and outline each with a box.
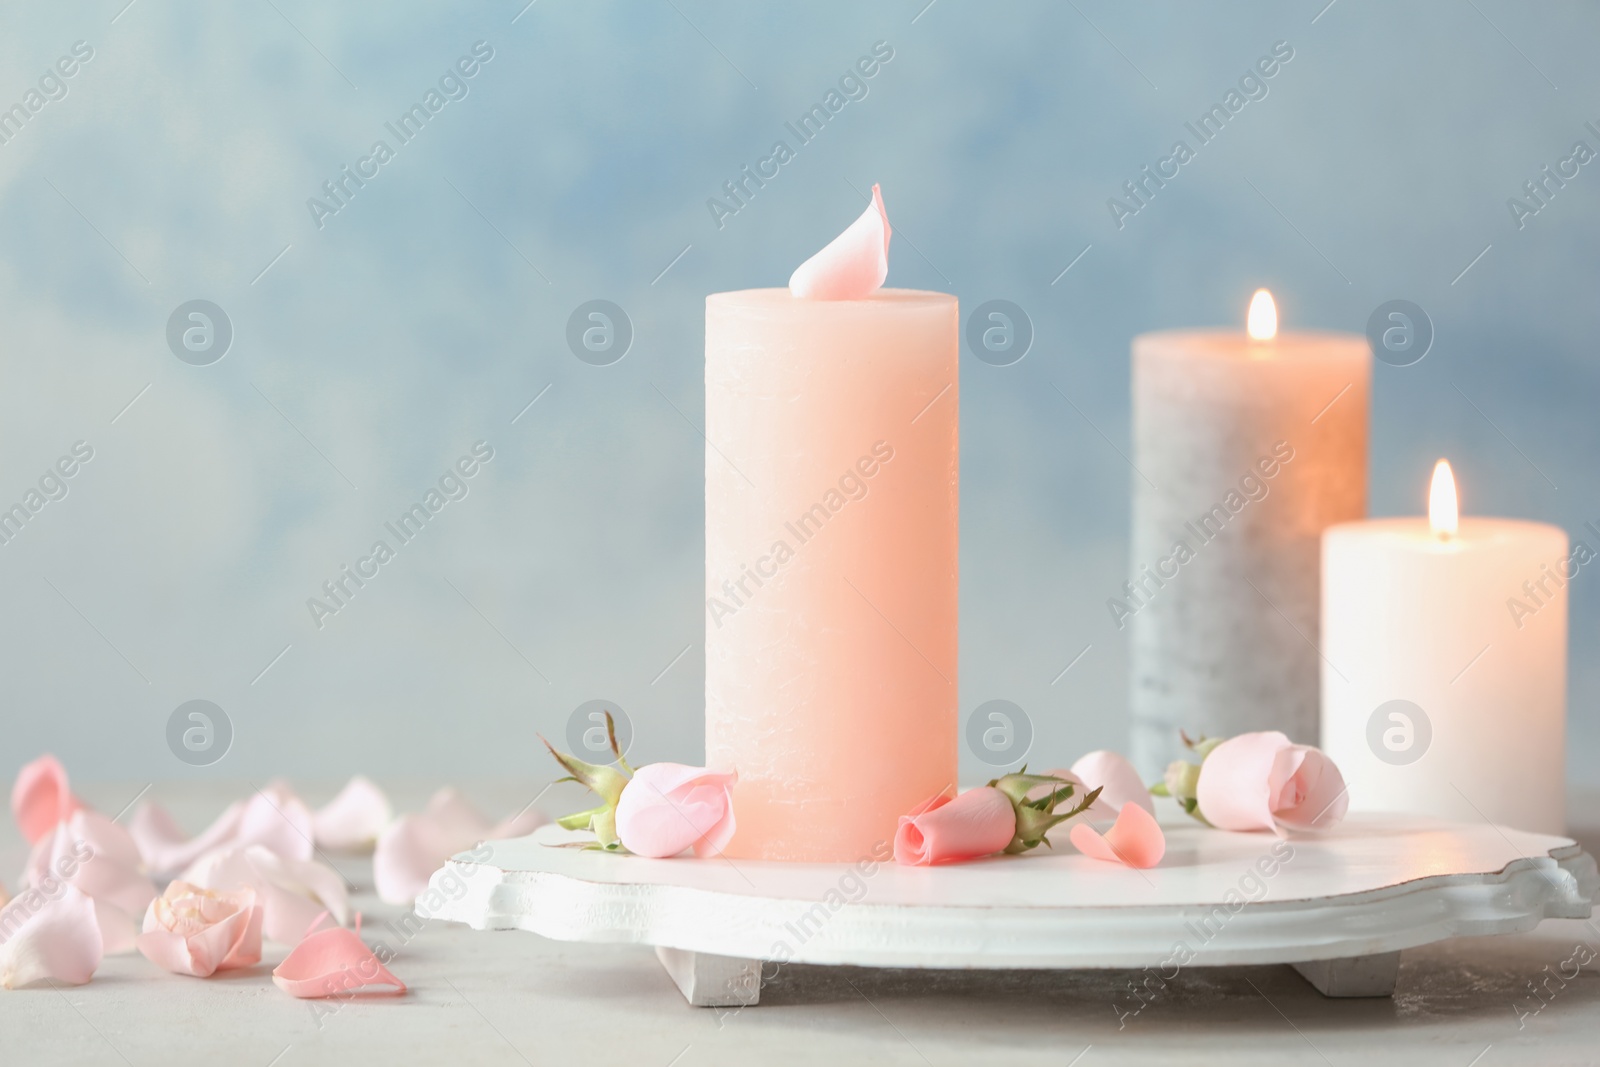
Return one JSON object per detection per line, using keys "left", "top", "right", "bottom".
{"left": 706, "top": 290, "right": 960, "bottom": 861}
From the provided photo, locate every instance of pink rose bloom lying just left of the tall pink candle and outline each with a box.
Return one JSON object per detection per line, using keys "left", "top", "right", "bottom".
{"left": 616, "top": 763, "right": 738, "bottom": 859}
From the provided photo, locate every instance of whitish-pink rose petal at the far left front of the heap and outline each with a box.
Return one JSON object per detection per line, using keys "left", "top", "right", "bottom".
{"left": 0, "top": 883, "right": 104, "bottom": 989}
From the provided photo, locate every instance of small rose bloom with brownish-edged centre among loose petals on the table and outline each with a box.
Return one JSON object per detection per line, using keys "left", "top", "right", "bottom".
{"left": 136, "top": 881, "right": 261, "bottom": 977}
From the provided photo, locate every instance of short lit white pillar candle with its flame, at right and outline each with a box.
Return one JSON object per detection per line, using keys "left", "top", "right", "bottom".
{"left": 1322, "top": 461, "right": 1579, "bottom": 833}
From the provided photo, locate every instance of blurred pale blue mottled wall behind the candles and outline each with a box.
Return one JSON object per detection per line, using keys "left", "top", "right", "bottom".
{"left": 0, "top": 0, "right": 1600, "bottom": 781}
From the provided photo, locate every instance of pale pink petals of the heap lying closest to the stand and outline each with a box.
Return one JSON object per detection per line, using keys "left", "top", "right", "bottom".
{"left": 373, "top": 789, "right": 546, "bottom": 904}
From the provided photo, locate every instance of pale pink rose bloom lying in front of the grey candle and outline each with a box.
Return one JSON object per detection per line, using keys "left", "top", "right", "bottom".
{"left": 1195, "top": 729, "right": 1350, "bottom": 837}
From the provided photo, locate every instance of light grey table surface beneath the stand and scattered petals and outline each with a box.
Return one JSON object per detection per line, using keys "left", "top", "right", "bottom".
{"left": 0, "top": 782, "right": 1600, "bottom": 1067}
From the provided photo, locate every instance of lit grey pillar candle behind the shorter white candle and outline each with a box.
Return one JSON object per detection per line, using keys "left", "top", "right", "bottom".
{"left": 1126, "top": 298, "right": 1371, "bottom": 777}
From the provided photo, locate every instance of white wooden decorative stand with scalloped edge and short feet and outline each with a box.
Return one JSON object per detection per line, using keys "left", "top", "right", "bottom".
{"left": 418, "top": 814, "right": 1600, "bottom": 1006}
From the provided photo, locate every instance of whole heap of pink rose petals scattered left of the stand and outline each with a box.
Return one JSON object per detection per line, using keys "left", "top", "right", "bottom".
{"left": 0, "top": 755, "right": 502, "bottom": 997}
